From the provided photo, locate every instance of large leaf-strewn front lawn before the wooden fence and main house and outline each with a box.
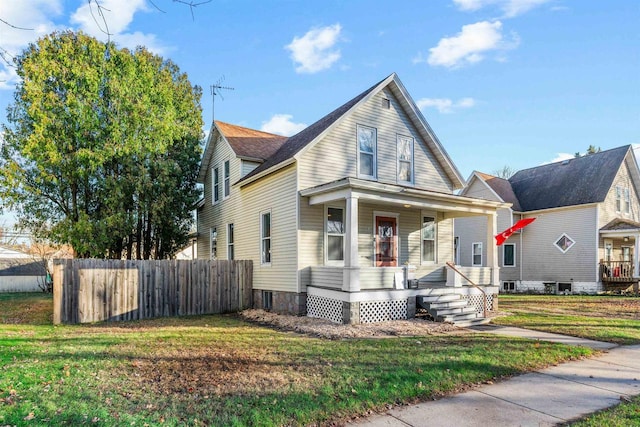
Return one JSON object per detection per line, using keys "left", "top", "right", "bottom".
{"left": 0, "top": 295, "right": 593, "bottom": 426}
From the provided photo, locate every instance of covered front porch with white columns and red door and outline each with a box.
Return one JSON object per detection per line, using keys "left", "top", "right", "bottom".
{"left": 300, "top": 178, "right": 506, "bottom": 323}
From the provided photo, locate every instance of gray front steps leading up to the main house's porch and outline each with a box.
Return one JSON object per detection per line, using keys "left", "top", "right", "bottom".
{"left": 416, "top": 291, "right": 489, "bottom": 327}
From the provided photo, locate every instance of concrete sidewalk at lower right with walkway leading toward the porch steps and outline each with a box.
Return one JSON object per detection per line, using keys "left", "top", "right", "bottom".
{"left": 349, "top": 326, "right": 640, "bottom": 427}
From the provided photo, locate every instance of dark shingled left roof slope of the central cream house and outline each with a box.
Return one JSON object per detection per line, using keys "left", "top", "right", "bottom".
{"left": 238, "top": 76, "right": 390, "bottom": 182}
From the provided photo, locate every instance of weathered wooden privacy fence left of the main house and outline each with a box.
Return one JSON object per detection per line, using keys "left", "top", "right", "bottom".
{"left": 53, "top": 259, "right": 253, "bottom": 324}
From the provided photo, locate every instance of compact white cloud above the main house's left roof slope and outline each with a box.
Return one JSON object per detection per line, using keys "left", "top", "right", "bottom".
{"left": 285, "top": 24, "right": 342, "bottom": 73}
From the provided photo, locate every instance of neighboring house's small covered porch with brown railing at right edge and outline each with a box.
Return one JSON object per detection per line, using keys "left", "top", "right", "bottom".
{"left": 598, "top": 219, "right": 640, "bottom": 292}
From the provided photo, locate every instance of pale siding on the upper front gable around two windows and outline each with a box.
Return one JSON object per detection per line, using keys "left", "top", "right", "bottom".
{"left": 299, "top": 89, "right": 453, "bottom": 192}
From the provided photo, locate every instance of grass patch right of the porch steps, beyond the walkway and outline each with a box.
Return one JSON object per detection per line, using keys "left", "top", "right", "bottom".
{"left": 493, "top": 295, "right": 640, "bottom": 345}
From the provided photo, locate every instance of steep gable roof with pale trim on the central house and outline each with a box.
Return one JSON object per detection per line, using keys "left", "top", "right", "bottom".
{"left": 238, "top": 73, "right": 464, "bottom": 188}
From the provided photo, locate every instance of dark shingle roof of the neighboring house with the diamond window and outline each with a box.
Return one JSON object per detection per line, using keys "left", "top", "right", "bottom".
{"left": 509, "top": 145, "right": 631, "bottom": 212}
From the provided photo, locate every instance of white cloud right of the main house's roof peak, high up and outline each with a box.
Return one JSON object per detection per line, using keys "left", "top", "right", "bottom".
{"left": 414, "top": 21, "right": 519, "bottom": 68}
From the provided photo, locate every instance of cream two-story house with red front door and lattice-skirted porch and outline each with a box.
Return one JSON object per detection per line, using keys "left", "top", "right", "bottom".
{"left": 197, "top": 74, "right": 508, "bottom": 323}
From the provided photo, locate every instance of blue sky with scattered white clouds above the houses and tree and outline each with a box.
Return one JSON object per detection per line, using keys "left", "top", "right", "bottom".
{"left": 0, "top": 0, "right": 640, "bottom": 186}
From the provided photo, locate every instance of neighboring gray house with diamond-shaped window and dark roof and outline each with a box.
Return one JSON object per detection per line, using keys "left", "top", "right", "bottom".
{"left": 455, "top": 145, "right": 640, "bottom": 293}
